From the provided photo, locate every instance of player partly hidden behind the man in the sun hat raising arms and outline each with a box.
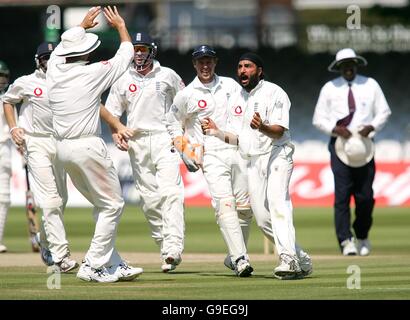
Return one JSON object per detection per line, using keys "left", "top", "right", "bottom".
{"left": 3, "top": 42, "right": 78, "bottom": 272}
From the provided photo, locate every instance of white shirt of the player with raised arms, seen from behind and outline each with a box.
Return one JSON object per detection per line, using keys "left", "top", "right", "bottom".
{"left": 47, "top": 36, "right": 134, "bottom": 139}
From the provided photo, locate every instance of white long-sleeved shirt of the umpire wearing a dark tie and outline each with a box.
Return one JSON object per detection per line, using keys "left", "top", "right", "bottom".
{"left": 313, "top": 75, "right": 391, "bottom": 136}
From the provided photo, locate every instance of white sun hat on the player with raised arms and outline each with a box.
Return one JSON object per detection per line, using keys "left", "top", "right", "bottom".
{"left": 54, "top": 27, "right": 101, "bottom": 58}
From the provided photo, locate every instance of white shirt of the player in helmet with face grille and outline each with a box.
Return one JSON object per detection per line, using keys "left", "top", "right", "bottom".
{"left": 105, "top": 60, "right": 185, "bottom": 132}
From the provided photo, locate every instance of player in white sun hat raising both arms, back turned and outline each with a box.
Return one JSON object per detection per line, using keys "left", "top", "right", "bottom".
{"left": 47, "top": 7, "right": 143, "bottom": 282}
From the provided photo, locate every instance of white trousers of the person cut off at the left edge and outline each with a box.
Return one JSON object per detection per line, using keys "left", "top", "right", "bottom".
{"left": 0, "top": 140, "right": 11, "bottom": 244}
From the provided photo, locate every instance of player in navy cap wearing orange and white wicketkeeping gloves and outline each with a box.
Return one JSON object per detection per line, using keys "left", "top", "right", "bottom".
{"left": 168, "top": 45, "right": 253, "bottom": 277}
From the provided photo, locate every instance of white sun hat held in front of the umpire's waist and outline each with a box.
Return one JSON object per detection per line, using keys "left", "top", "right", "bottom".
{"left": 335, "top": 132, "right": 374, "bottom": 168}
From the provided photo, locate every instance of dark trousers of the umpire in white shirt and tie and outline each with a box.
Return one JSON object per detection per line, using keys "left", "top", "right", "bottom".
{"left": 329, "top": 137, "right": 375, "bottom": 244}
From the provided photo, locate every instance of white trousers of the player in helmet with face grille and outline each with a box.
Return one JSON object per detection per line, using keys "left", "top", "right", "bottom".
{"left": 128, "top": 131, "right": 185, "bottom": 259}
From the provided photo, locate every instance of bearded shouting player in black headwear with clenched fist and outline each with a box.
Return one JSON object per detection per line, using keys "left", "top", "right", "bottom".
{"left": 202, "top": 53, "right": 312, "bottom": 279}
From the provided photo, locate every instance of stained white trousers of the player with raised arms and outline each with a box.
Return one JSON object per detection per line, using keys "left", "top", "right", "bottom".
{"left": 57, "top": 136, "right": 124, "bottom": 269}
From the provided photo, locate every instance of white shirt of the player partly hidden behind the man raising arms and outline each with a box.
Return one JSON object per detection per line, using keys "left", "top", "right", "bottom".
{"left": 3, "top": 70, "right": 54, "bottom": 135}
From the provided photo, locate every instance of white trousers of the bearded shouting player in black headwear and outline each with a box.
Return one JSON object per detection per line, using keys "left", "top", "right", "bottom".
{"left": 248, "top": 143, "right": 297, "bottom": 258}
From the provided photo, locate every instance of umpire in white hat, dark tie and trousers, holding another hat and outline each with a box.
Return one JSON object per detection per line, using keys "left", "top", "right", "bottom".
{"left": 313, "top": 48, "right": 391, "bottom": 256}
